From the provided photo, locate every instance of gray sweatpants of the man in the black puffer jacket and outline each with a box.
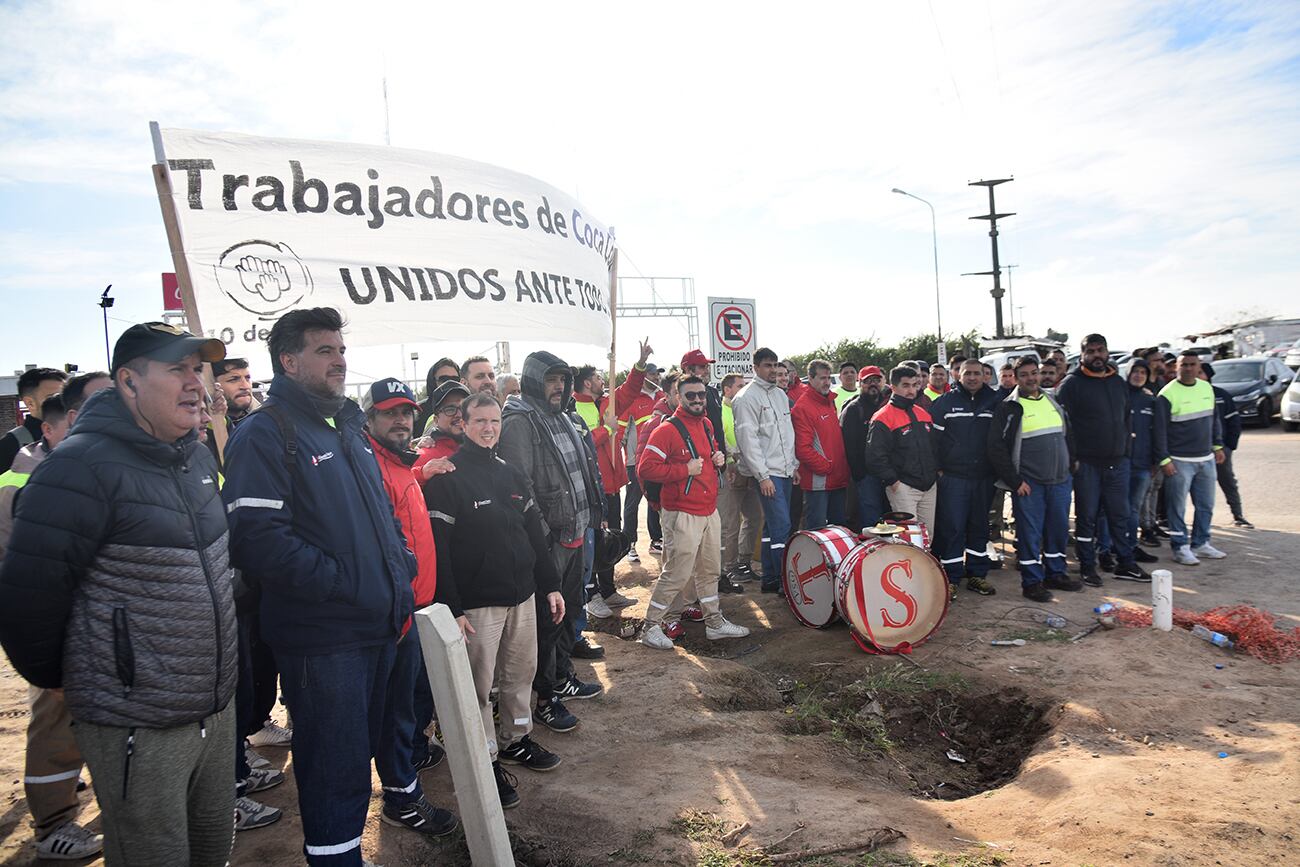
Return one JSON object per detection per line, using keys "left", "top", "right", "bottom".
{"left": 73, "top": 702, "right": 235, "bottom": 867}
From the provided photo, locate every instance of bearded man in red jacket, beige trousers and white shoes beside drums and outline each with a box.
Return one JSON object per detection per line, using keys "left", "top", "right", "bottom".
{"left": 637, "top": 377, "right": 749, "bottom": 650}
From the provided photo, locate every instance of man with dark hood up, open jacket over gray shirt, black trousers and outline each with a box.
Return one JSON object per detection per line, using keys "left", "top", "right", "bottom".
{"left": 497, "top": 352, "right": 605, "bottom": 732}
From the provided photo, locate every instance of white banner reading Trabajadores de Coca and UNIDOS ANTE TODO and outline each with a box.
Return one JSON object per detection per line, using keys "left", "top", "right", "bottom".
{"left": 153, "top": 125, "right": 615, "bottom": 355}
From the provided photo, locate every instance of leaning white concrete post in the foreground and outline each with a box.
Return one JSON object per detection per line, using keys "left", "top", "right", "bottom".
{"left": 415, "top": 604, "right": 515, "bottom": 867}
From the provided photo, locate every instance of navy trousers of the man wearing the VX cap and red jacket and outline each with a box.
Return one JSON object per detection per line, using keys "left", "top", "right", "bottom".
{"left": 374, "top": 634, "right": 429, "bottom": 807}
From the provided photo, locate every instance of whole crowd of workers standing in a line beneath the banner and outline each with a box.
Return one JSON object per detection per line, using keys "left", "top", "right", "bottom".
{"left": 0, "top": 308, "right": 1249, "bottom": 866}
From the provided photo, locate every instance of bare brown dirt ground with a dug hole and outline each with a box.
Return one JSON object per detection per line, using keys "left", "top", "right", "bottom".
{"left": 0, "top": 428, "right": 1300, "bottom": 867}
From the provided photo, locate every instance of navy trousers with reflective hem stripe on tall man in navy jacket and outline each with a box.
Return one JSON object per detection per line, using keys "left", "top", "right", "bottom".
{"left": 286, "top": 643, "right": 397, "bottom": 867}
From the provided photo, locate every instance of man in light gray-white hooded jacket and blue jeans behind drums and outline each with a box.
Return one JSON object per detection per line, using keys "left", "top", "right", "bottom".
{"left": 732, "top": 347, "right": 800, "bottom": 593}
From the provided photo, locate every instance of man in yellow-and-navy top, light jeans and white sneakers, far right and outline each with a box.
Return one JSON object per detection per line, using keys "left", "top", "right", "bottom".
{"left": 1156, "top": 350, "right": 1227, "bottom": 565}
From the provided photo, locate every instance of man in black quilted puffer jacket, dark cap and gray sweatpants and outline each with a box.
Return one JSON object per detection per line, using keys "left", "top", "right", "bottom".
{"left": 0, "top": 322, "right": 237, "bottom": 867}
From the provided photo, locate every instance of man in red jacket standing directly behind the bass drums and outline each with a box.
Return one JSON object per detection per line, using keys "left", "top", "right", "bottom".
{"left": 790, "top": 359, "right": 849, "bottom": 529}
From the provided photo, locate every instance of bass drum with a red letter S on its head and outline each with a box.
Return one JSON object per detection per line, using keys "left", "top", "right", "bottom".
{"left": 835, "top": 538, "right": 948, "bottom": 654}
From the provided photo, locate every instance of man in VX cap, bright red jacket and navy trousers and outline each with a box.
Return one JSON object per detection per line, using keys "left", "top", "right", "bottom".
{"left": 361, "top": 378, "right": 456, "bottom": 836}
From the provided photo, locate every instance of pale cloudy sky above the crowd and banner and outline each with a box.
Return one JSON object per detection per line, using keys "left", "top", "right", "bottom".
{"left": 0, "top": 0, "right": 1300, "bottom": 376}
